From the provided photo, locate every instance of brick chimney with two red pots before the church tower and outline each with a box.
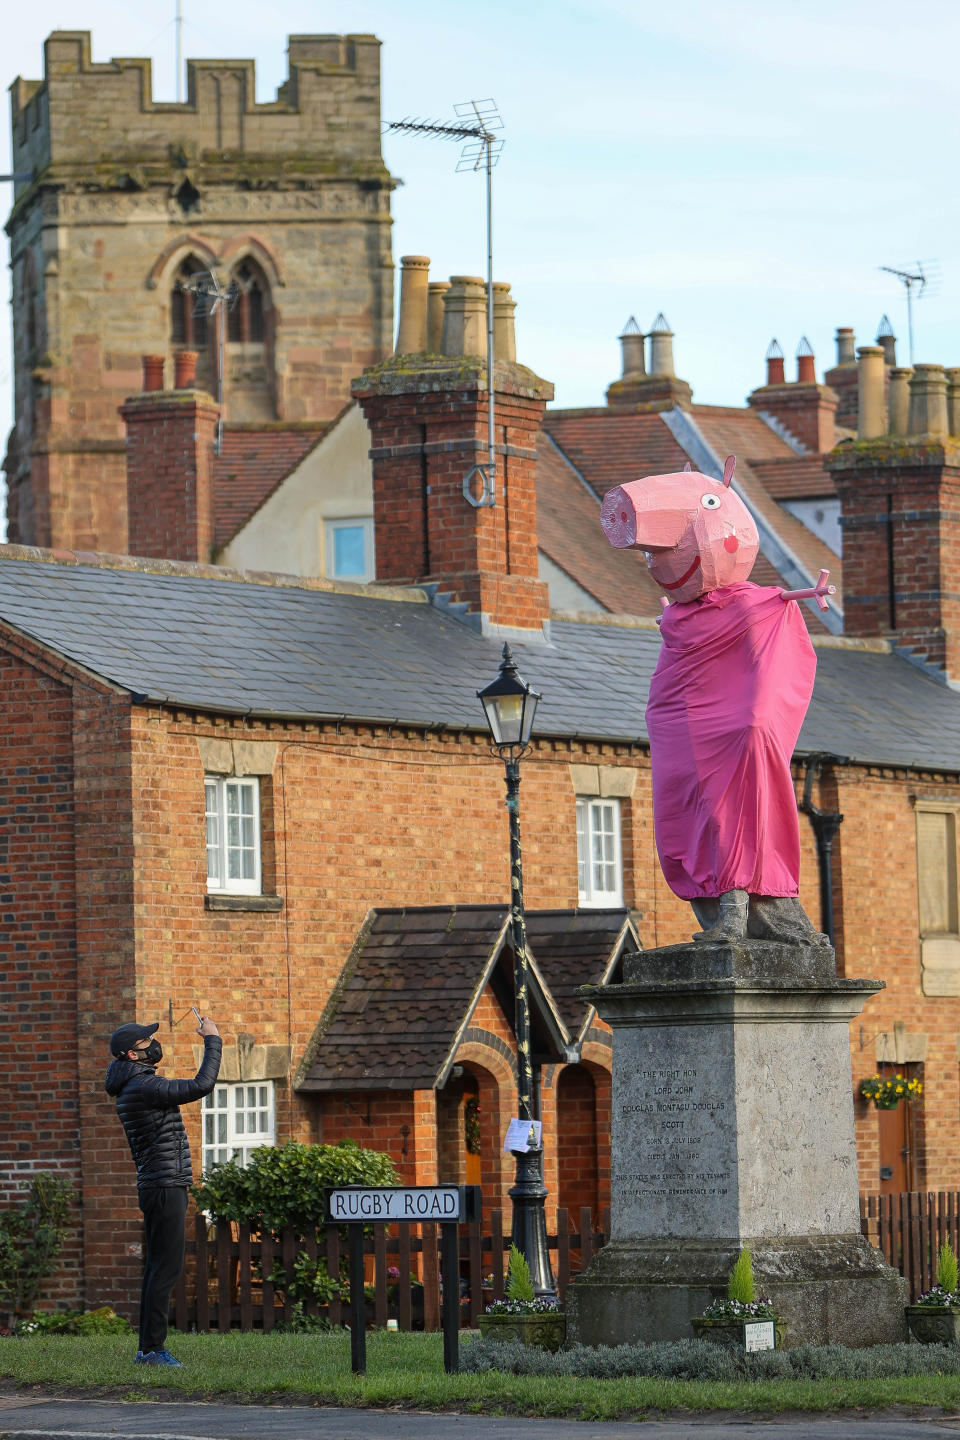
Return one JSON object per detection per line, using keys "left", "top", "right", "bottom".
{"left": 119, "top": 351, "right": 219, "bottom": 562}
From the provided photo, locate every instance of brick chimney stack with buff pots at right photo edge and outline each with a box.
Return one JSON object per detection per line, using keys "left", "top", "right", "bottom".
{"left": 825, "top": 360, "right": 960, "bottom": 680}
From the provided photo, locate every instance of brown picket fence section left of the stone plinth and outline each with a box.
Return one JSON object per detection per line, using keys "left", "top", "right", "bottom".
{"left": 170, "top": 1207, "right": 610, "bottom": 1332}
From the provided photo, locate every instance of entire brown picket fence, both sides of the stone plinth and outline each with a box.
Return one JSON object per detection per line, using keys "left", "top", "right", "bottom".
{"left": 170, "top": 1189, "right": 960, "bottom": 1331}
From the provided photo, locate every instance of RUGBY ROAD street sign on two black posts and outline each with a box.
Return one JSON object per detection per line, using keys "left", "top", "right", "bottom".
{"left": 325, "top": 1185, "right": 481, "bottom": 1375}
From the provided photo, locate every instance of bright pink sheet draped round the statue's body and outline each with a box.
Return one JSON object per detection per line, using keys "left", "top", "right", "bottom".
{"left": 646, "top": 582, "right": 816, "bottom": 900}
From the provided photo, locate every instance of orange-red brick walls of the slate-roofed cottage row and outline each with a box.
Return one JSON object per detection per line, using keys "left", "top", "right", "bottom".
{"left": 0, "top": 641, "right": 960, "bottom": 1312}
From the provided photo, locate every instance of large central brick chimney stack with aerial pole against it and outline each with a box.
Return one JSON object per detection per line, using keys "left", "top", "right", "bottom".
{"left": 353, "top": 260, "right": 553, "bottom": 634}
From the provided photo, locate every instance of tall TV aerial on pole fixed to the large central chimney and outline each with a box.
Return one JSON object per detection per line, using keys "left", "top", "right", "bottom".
{"left": 384, "top": 99, "right": 504, "bottom": 510}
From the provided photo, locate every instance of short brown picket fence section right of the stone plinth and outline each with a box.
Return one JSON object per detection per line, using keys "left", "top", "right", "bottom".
{"left": 861, "top": 1189, "right": 960, "bottom": 1302}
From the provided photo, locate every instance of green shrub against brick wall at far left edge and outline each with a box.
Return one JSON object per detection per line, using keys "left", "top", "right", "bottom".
{"left": 0, "top": 1175, "right": 73, "bottom": 1315}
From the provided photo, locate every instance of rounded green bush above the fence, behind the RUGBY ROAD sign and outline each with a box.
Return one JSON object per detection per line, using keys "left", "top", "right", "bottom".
{"left": 193, "top": 1139, "right": 397, "bottom": 1236}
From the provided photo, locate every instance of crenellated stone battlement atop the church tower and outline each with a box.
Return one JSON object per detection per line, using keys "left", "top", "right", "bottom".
{"left": 10, "top": 30, "right": 383, "bottom": 185}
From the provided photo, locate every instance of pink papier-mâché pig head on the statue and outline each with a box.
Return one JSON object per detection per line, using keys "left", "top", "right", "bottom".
{"left": 600, "top": 455, "right": 760, "bottom": 602}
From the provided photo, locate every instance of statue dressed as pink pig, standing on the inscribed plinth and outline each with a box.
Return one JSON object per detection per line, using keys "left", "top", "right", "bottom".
{"left": 600, "top": 455, "right": 833, "bottom": 945}
